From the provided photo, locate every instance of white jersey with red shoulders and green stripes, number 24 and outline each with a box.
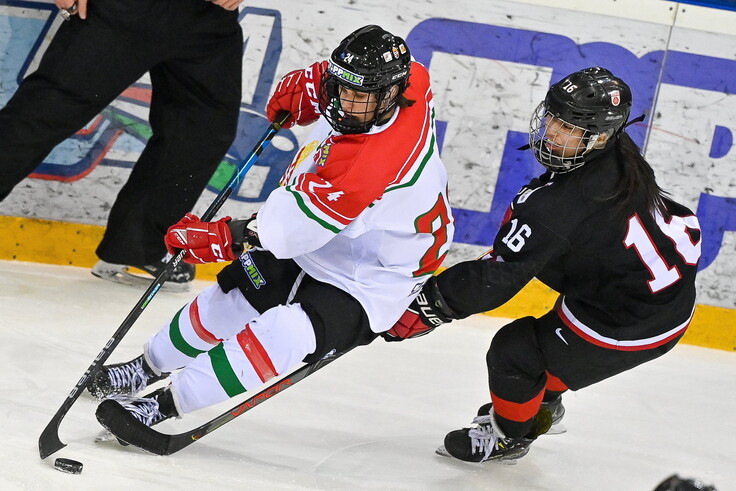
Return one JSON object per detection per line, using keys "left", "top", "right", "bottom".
{"left": 258, "top": 63, "right": 454, "bottom": 332}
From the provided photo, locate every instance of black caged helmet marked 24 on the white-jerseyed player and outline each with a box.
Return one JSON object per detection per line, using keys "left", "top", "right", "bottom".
{"left": 319, "top": 25, "right": 411, "bottom": 134}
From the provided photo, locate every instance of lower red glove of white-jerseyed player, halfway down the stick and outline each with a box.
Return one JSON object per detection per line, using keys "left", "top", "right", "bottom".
{"left": 164, "top": 213, "right": 237, "bottom": 264}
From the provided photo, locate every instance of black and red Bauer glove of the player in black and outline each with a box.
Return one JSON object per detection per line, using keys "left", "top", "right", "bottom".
{"left": 381, "top": 276, "right": 457, "bottom": 341}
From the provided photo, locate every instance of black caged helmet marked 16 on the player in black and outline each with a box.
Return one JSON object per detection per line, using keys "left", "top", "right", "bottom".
{"left": 529, "top": 67, "right": 631, "bottom": 173}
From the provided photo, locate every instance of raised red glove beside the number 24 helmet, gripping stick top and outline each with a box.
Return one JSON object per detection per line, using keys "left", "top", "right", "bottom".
{"left": 266, "top": 61, "right": 327, "bottom": 128}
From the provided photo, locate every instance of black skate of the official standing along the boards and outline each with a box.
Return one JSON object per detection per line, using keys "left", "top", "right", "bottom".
{"left": 92, "top": 256, "right": 195, "bottom": 293}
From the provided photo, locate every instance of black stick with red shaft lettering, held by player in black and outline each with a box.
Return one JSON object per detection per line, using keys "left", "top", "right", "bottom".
{"left": 95, "top": 350, "right": 350, "bottom": 455}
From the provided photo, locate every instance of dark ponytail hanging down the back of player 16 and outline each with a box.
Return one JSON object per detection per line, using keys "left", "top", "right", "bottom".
{"left": 610, "top": 131, "right": 669, "bottom": 219}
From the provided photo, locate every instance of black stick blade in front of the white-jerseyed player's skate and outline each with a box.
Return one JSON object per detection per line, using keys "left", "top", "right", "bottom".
{"left": 95, "top": 399, "right": 171, "bottom": 455}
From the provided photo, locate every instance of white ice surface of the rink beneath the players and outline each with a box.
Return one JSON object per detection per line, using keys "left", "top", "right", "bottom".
{"left": 0, "top": 261, "right": 736, "bottom": 491}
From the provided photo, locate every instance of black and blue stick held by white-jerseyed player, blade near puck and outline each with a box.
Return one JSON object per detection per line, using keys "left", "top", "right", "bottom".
{"left": 38, "top": 111, "right": 290, "bottom": 459}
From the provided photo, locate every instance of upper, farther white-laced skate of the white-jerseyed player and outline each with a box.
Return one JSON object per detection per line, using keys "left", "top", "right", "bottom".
{"left": 87, "top": 355, "right": 169, "bottom": 400}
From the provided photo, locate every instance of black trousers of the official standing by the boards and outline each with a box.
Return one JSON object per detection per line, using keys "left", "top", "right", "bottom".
{"left": 0, "top": 0, "right": 243, "bottom": 264}
